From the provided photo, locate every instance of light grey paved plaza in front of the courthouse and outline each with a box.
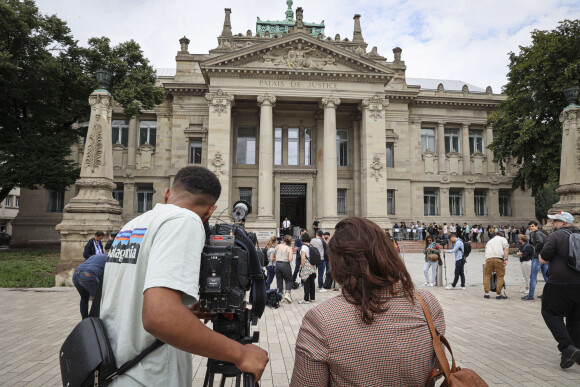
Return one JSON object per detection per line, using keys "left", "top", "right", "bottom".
{"left": 0, "top": 251, "right": 580, "bottom": 387}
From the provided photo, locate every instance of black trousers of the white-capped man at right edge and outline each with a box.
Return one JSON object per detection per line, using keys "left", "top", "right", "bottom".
{"left": 542, "top": 282, "right": 580, "bottom": 352}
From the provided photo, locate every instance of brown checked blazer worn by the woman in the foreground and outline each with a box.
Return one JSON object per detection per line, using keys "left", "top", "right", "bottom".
{"left": 290, "top": 283, "right": 445, "bottom": 387}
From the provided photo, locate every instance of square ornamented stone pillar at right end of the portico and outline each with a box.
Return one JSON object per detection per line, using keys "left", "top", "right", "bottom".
{"left": 359, "top": 95, "right": 390, "bottom": 228}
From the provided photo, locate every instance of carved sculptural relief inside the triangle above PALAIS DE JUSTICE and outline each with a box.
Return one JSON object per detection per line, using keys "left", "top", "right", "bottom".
{"left": 262, "top": 43, "right": 336, "bottom": 70}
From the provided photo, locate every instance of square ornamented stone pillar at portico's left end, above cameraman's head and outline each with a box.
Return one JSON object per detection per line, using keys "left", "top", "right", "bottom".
{"left": 205, "top": 89, "right": 234, "bottom": 215}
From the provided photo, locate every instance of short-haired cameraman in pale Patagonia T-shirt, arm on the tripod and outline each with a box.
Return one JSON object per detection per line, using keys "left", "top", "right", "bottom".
{"left": 101, "top": 167, "right": 268, "bottom": 387}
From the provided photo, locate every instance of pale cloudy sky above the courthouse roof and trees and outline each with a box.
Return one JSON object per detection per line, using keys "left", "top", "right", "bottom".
{"left": 36, "top": 0, "right": 580, "bottom": 92}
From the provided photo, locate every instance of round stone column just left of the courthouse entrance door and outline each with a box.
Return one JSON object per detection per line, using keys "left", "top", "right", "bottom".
{"left": 257, "top": 94, "right": 276, "bottom": 228}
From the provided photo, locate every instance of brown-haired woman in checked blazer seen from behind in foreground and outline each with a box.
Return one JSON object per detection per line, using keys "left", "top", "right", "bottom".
{"left": 291, "top": 218, "right": 445, "bottom": 387}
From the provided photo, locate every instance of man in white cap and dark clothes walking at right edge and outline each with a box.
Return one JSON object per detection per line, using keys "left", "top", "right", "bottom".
{"left": 539, "top": 212, "right": 580, "bottom": 368}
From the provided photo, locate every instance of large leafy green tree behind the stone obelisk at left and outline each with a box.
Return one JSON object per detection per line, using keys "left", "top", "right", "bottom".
{"left": 0, "top": 0, "right": 164, "bottom": 201}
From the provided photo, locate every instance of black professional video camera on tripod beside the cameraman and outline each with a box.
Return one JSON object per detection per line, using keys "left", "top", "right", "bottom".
{"left": 199, "top": 200, "right": 266, "bottom": 387}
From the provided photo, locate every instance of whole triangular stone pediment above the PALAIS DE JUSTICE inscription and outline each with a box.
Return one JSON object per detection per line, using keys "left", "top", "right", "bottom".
{"left": 200, "top": 33, "right": 395, "bottom": 83}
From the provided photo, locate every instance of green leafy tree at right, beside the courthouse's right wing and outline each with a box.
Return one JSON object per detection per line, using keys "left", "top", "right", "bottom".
{"left": 488, "top": 20, "right": 580, "bottom": 196}
